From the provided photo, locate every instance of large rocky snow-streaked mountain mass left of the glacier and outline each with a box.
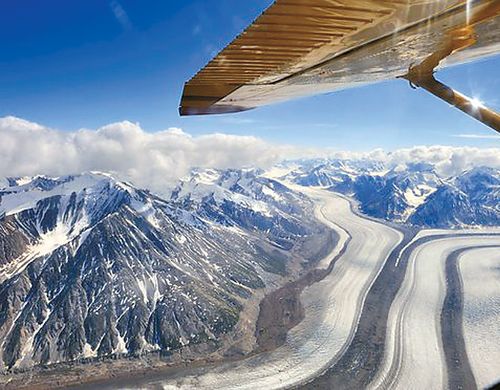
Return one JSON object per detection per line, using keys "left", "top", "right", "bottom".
{"left": 0, "top": 171, "right": 314, "bottom": 369}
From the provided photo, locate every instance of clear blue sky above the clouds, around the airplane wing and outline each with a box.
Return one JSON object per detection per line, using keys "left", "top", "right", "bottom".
{"left": 0, "top": 0, "right": 500, "bottom": 150}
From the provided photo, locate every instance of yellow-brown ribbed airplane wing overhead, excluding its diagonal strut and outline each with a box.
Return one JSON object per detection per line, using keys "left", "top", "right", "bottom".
{"left": 180, "top": 0, "right": 500, "bottom": 131}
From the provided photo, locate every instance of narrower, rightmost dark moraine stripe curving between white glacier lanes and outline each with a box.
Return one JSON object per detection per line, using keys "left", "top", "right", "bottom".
{"left": 441, "top": 245, "right": 500, "bottom": 389}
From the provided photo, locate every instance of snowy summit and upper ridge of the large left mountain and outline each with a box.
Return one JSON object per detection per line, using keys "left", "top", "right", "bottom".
{"left": 0, "top": 172, "right": 197, "bottom": 282}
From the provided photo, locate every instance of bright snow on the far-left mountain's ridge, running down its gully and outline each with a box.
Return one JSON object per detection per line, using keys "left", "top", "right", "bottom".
{"left": 0, "top": 173, "right": 143, "bottom": 281}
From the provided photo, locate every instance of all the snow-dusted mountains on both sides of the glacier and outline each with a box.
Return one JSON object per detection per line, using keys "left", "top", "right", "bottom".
{"left": 0, "top": 159, "right": 500, "bottom": 370}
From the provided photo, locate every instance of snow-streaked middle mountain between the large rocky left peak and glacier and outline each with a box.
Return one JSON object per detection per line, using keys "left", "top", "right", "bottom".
{"left": 171, "top": 169, "right": 313, "bottom": 249}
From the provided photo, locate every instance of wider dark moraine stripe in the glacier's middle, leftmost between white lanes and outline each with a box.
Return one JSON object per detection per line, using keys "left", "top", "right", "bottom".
{"left": 296, "top": 233, "right": 500, "bottom": 389}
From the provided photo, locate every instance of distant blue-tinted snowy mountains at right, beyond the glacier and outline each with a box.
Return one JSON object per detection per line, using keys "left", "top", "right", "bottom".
{"left": 287, "top": 160, "right": 500, "bottom": 228}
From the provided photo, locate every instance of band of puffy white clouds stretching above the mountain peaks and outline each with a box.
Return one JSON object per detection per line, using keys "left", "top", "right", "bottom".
{"left": 0, "top": 117, "right": 500, "bottom": 192}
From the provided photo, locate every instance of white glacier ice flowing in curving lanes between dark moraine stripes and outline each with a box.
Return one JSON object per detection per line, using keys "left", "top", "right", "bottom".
{"left": 95, "top": 187, "right": 500, "bottom": 389}
